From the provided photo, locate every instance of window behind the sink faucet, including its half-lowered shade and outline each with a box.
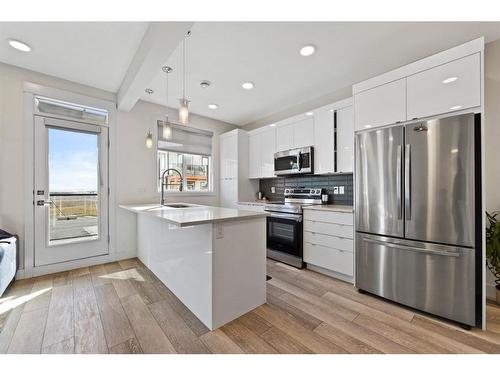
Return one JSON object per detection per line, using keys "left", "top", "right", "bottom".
{"left": 158, "top": 121, "right": 213, "bottom": 192}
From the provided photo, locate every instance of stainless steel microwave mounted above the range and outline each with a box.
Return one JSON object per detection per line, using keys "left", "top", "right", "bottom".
{"left": 274, "top": 146, "right": 314, "bottom": 176}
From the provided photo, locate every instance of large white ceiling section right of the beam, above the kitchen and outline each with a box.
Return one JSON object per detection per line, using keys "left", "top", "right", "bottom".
{"left": 142, "top": 22, "right": 500, "bottom": 125}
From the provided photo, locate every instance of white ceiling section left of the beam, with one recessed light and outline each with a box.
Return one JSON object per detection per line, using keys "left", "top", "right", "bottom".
{"left": 0, "top": 22, "right": 148, "bottom": 92}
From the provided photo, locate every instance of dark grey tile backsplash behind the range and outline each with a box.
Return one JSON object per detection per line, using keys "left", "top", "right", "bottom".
{"left": 259, "top": 173, "right": 354, "bottom": 205}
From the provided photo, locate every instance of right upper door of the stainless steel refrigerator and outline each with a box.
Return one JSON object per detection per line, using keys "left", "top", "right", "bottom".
{"left": 405, "top": 113, "right": 475, "bottom": 247}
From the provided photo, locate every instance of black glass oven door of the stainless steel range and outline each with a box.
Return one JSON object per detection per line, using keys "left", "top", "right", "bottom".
{"left": 267, "top": 213, "right": 302, "bottom": 258}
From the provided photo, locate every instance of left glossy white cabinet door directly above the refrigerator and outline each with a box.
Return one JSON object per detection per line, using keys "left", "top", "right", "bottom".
{"left": 354, "top": 78, "right": 406, "bottom": 130}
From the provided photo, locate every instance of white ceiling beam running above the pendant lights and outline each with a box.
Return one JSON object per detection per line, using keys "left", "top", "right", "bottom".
{"left": 118, "top": 22, "right": 194, "bottom": 111}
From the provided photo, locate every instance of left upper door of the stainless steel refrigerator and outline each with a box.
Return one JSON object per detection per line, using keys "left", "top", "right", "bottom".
{"left": 355, "top": 126, "right": 404, "bottom": 237}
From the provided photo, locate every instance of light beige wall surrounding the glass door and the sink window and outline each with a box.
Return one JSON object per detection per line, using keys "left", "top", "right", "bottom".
{"left": 0, "top": 63, "right": 235, "bottom": 268}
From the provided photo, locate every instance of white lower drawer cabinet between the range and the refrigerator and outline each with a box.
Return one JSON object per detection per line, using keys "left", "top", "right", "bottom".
{"left": 304, "top": 209, "right": 354, "bottom": 278}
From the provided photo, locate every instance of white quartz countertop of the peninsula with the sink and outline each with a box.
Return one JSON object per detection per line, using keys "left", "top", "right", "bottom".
{"left": 120, "top": 203, "right": 267, "bottom": 227}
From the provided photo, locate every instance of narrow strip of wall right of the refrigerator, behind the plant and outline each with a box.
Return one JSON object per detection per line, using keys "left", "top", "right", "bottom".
{"left": 484, "top": 40, "right": 500, "bottom": 298}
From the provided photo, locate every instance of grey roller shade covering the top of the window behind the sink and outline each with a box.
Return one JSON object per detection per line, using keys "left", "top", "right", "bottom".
{"left": 158, "top": 120, "right": 214, "bottom": 156}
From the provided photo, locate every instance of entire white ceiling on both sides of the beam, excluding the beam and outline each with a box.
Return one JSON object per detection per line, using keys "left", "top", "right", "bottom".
{"left": 0, "top": 22, "right": 500, "bottom": 126}
